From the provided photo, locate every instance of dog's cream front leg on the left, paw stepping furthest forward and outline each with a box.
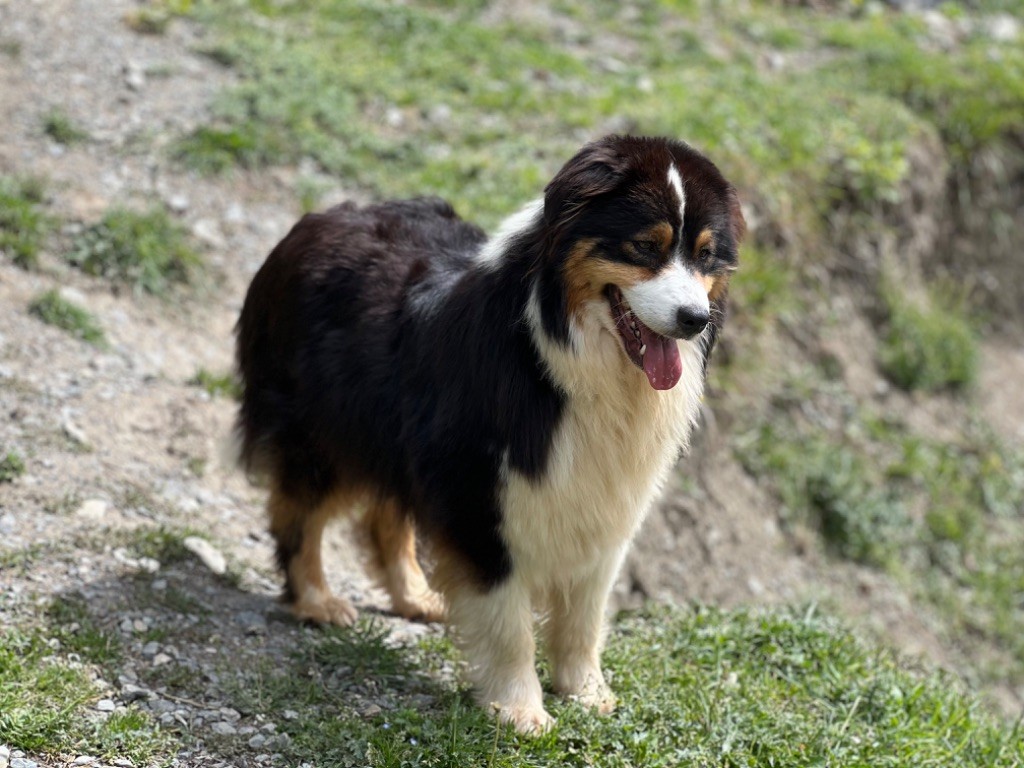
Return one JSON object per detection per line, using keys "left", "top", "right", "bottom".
{"left": 445, "top": 579, "right": 554, "bottom": 734}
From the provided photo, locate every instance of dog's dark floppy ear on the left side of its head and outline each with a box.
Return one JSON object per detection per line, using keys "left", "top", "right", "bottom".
{"left": 544, "top": 136, "right": 629, "bottom": 228}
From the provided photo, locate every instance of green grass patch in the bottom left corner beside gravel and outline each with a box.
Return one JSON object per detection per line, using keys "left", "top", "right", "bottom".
{"left": 0, "top": 628, "right": 171, "bottom": 765}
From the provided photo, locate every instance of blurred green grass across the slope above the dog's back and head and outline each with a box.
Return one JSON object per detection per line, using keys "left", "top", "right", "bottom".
{"left": 176, "top": 0, "right": 954, "bottom": 231}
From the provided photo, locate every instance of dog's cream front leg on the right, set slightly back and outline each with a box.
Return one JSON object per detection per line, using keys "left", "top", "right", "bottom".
{"left": 545, "top": 552, "right": 623, "bottom": 714}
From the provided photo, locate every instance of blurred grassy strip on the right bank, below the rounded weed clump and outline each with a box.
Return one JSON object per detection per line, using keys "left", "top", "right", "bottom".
{"left": 738, "top": 397, "right": 1024, "bottom": 682}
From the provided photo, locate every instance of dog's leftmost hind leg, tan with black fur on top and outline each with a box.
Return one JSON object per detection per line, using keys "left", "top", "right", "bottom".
{"left": 267, "top": 489, "right": 357, "bottom": 627}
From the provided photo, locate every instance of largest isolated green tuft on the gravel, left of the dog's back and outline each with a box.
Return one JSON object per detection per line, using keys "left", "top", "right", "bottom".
{"left": 68, "top": 208, "right": 202, "bottom": 296}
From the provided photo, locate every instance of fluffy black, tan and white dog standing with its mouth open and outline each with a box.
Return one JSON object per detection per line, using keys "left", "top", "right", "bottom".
{"left": 237, "top": 135, "right": 745, "bottom": 733}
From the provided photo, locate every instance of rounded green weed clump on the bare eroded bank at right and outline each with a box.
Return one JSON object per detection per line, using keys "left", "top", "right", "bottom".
{"left": 879, "top": 282, "right": 979, "bottom": 391}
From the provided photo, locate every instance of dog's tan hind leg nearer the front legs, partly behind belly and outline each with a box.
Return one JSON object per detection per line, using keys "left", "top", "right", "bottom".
{"left": 362, "top": 500, "right": 444, "bottom": 622}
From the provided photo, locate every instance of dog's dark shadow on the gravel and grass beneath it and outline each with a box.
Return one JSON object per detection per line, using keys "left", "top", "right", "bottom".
{"left": 44, "top": 556, "right": 456, "bottom": 759}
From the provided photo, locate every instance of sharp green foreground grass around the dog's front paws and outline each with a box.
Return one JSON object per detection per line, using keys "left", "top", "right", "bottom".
{"left": 220, "top": 608, "right": 1024, "bottom": 768}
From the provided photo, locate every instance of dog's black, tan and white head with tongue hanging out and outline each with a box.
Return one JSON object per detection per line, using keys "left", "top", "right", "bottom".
{"left": 543, "top": 136, "right": 745, "bottom": 389}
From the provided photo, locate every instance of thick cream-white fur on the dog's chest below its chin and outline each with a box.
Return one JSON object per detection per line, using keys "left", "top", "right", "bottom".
{"left": 502, "top": 296, "right": 703, "bottom": 591}
